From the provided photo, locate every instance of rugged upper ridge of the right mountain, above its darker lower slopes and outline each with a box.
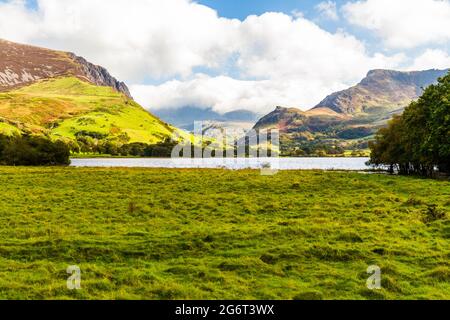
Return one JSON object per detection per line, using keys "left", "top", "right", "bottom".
{"left": 316, "top": 69, "right": 449, "bottom": 114}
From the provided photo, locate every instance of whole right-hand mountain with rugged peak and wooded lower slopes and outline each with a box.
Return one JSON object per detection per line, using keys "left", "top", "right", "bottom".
{"left": 254, "top": 70, "right": 449, "bottom": 155}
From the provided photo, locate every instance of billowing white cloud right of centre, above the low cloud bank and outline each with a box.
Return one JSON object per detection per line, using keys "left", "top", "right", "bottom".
{"left": 237, "top": 13, "right": 399, "bottom": 84}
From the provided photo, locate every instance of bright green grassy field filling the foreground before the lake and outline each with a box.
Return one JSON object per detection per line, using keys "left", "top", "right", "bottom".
{"left": 0, "top": 167, "right": 450, "bottom": 299}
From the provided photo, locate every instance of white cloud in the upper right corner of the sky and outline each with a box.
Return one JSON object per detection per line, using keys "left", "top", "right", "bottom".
{"left": 343, "top": 0, "right": 450, "bottom": 49}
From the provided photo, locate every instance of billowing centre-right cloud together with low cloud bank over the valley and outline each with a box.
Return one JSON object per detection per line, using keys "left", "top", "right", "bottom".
{"left": 131, "top": 13, "right": 405, "bottom": 112}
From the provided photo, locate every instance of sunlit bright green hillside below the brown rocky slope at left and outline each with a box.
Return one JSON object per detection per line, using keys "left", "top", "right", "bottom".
{"left": 0, "top": 77, "right": 176, "bottom": 144}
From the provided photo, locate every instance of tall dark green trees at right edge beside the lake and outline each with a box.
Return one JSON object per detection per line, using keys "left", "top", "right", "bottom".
{"left": 370, "top": 74, "right": 450, "bottom": 176}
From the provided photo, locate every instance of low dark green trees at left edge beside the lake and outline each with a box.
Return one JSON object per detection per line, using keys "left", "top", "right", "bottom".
{"left": 0, "top": 135, "right": 70, "bottom": 166}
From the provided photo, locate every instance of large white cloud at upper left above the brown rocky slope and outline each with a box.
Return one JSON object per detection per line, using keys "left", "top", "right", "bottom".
{"left": 0, "top": 0, "right": 239, "bottom": 81}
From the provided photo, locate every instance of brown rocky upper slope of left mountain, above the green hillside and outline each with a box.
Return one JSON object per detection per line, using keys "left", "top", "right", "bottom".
{"left": 0, "top": 39, "right": 131, "bottom": 98}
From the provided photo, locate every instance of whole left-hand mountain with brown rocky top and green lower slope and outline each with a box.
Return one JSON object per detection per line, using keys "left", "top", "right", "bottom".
{"left": 0, "top": 40, "right": 177, "bottom": 143}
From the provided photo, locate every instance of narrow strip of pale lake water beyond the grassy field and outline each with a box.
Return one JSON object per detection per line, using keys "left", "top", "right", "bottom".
{"left": 71, "top": 158, "right": 370, "bottom": 171}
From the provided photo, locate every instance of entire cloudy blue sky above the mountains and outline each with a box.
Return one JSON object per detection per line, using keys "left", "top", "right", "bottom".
{"left": 0, "top": 0, "right": 450, "bottom": 114}
